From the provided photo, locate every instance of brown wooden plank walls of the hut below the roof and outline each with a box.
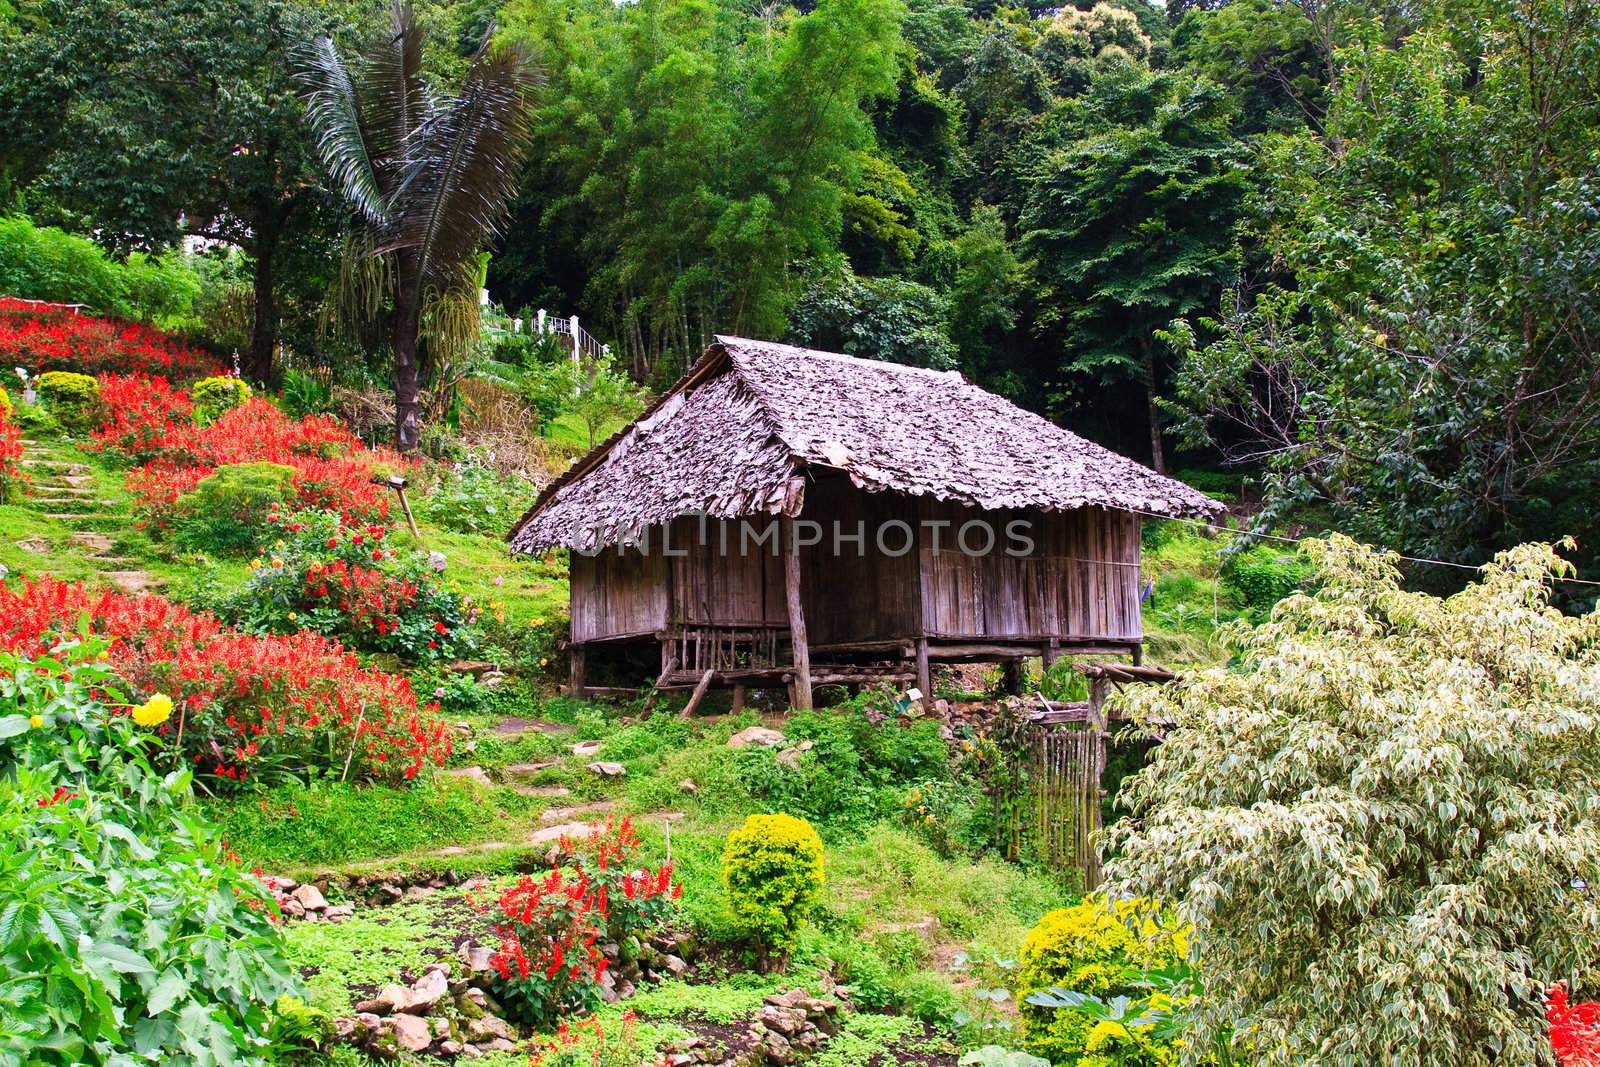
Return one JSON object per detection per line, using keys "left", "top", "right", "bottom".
{"left": 571, "top": 475, "right": 1142, "bottom": 645}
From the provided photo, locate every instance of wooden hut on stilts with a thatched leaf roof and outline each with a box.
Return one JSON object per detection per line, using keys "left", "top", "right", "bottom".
{"left": 510, "top": 338, "right": 1216, "bottom": 707}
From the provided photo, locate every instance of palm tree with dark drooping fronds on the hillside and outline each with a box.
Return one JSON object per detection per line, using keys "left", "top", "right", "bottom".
{"left": 299, "top": 0, "right": 538, "bottom": 451}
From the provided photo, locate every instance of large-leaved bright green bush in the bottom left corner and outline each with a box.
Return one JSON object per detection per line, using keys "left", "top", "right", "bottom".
{"left": 0, "top": 638, "right": 298, "bottom": 1065}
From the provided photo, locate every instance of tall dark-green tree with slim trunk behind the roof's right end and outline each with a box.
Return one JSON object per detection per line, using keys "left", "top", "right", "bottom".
{"left": 1022, "top": 64, "right": 1245, "bottom": 470}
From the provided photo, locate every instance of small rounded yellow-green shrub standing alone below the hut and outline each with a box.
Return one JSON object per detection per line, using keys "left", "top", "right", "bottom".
{"left": 722, "top": 814, "right": 824, "bottom": 969}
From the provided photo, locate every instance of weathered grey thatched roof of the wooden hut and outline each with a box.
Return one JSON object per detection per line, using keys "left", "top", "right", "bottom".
{"left": 510, "top": 338, "right": 1219, "bottom": 552}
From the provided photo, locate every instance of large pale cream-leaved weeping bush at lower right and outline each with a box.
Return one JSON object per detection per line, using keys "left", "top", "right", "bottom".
{"left": 1107, "top": 537, "right": 1600, "bottom": 1067}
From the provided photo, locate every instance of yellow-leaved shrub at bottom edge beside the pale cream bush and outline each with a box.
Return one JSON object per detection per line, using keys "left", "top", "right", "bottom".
{"left": 1016, "top": 897, "right": 1189, "bottom": 1067}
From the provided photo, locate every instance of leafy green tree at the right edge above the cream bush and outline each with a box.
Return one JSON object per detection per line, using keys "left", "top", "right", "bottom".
{"left": 1173, "top": 2, "right": 1600, "bottom": 572}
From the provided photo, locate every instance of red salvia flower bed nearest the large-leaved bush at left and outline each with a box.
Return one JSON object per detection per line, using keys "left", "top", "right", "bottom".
{"left": 0, "top": 577, "right": 451, "bottom": 782}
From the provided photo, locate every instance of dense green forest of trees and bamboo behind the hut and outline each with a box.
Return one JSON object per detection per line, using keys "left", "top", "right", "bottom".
{"left": 0, "top": 0, "right": 1600, "bottom": 571}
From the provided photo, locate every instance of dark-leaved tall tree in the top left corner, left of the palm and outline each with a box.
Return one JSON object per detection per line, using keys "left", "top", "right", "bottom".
{"left": 0, "top": 0, "right": 336, "bottom": 379}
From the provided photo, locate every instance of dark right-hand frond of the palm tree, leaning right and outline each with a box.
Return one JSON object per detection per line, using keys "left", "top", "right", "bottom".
{"left": 395, "top": 39, "right": 538, "bottom": 291}
